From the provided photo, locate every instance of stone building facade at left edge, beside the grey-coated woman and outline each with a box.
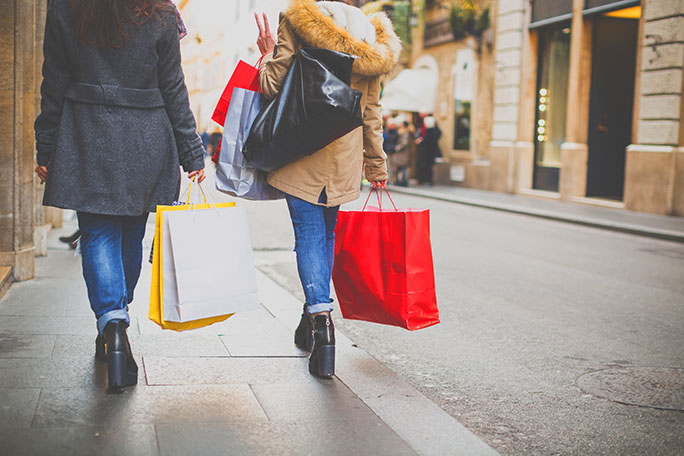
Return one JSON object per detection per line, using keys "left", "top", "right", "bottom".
{"left": 0, "top": 0, "right": 61, "bottom": 295}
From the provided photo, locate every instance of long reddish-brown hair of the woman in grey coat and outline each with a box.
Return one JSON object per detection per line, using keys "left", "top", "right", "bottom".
{"left": 69, "top": 0, "right": 174, "bottom": 49}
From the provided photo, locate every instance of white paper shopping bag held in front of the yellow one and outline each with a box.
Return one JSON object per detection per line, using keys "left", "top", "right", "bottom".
{"left": 162, "top": 207, "right": 259, "bottom": 323}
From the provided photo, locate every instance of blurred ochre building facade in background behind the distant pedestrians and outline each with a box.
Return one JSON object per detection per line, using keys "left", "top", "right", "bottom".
{"left": 383, "top": 0, "right": 496, "bottom": 187}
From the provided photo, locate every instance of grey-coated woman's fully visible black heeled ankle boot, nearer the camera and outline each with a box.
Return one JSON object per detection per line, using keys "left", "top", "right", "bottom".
{"left": 104, "top": 320, "right": 138, "bottom": 388}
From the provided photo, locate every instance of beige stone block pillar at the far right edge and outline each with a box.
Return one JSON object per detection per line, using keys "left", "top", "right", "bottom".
{"left": 625, "top": 0, "right": 684, "bottom": 215}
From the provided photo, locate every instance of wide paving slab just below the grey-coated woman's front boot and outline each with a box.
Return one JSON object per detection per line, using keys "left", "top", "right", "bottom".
{"left": 33, "top": 384, "right": 268, "bottom": 428}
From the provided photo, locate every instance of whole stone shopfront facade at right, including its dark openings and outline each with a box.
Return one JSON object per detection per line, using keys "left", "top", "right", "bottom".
{"left": 484, "top": 0, "right": 684, "bottom": 215}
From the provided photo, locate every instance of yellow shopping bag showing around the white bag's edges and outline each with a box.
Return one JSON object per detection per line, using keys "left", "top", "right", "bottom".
{"left": 149, "top": 179, "right": 235, "bottom": 331}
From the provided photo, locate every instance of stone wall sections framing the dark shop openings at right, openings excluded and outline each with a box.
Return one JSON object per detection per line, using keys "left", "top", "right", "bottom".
{"left": 484, "top": 0, "right": 684, "bottom": 215}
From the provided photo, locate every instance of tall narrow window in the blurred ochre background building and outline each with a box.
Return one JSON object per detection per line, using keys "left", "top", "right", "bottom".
{"left": 453, "top": 49, "right": 477, "bottom": 150}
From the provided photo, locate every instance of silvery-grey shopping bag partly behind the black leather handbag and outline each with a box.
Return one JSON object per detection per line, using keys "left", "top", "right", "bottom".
{"left": 216, "top": 87, "right": 285, "bottom": 200}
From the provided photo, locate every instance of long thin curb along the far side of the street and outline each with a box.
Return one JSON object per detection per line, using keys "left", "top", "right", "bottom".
{"left": 387, "top": 185, "right": 684, "bottom": 243}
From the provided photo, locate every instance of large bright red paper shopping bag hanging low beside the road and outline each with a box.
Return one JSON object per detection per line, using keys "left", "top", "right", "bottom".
{"left": 332, "top": 186, "right": 439, "bottom": 330}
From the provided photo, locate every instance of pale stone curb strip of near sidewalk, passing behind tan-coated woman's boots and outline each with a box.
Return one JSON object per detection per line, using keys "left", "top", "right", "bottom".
{"left": 257, "top": 269, "right": 499, "bottom": 456}
